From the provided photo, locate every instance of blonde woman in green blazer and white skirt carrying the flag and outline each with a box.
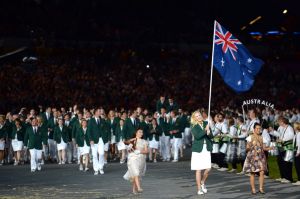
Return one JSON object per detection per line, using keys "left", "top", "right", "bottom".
{"left": 191, "top": 111, "right": 213, "bottom": 195}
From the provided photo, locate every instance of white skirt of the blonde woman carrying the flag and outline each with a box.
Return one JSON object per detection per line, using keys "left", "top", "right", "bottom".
{"left": 191, "top": 144, "right": 211, "bottom": 171}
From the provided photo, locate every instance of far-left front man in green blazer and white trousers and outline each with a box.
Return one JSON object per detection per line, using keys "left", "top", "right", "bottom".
{"left": 24, "top": 118, "right": 47, "bottom": 172}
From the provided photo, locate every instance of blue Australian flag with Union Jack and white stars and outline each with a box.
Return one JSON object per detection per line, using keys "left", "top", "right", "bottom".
{"left": 213, "top": 22, "right": 264, "bottom": 92}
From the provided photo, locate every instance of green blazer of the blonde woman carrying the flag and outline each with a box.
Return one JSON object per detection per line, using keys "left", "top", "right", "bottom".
{"left": 191, "top": 122, "right": 213, "bottom": 153}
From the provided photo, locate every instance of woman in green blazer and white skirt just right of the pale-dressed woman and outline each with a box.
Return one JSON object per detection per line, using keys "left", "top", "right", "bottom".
{"left": 148, "top": 119, "right": 162, "bottom": 163}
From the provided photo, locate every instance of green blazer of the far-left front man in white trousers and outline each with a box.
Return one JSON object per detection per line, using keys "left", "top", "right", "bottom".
{"left": 24, "top": 126, "right": 47, "bottom": 150}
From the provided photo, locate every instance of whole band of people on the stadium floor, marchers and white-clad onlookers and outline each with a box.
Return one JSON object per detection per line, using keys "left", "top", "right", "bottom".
{"left": 0, "top": 96, "right": 300, "bottom": 194}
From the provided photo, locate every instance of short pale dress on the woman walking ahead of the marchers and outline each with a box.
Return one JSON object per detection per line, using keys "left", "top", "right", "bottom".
{"left": 123, "top": 139, "right": 148, "bottom": 181}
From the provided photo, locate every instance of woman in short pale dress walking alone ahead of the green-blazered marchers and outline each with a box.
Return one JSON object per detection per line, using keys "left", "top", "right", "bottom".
{"left": 124, "top": 129, "right": 148, "bottom": 194}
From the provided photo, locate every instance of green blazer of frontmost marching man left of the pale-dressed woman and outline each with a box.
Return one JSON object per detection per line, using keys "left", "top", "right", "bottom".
{"left": 88, "top": 117, "right": 108, "bottom": 144}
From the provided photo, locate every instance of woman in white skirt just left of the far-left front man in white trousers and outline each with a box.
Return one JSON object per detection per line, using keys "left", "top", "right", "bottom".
{"left": 11, "top": 119, "right": 25, "bottom": 165}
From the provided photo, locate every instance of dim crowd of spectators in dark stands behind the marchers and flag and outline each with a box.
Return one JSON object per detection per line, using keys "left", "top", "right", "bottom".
{"left": 0, "top": 46, "right": 300, "bottom": 112}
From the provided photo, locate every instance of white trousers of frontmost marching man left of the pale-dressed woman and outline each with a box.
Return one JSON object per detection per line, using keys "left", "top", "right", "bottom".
{"left": 91, "top": 138, "right": 104, "bottom": 171}
